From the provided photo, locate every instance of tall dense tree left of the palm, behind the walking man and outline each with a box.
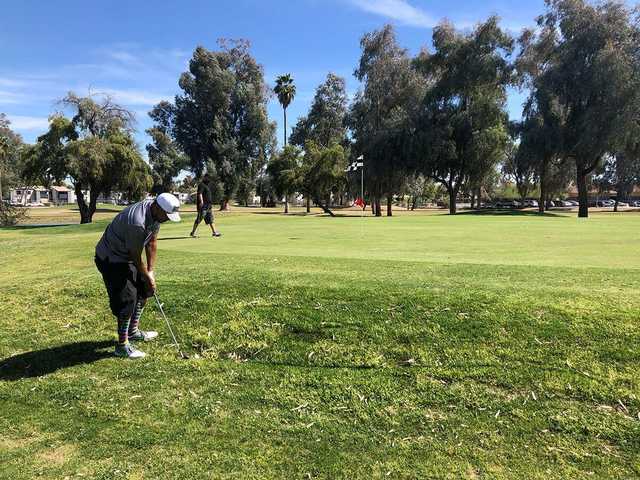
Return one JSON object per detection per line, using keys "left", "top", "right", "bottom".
{"left": 162, "top": 40, "right": 275, "bottom": 209}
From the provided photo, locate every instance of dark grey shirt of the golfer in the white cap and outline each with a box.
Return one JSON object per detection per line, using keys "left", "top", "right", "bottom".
{"left": 96, "top": 200, "right": 160, "bottom": 263}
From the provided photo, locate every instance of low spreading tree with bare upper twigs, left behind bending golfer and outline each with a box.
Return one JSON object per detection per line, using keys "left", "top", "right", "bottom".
{"left": 24, "top": 93, "right": 152, "bottom": 223}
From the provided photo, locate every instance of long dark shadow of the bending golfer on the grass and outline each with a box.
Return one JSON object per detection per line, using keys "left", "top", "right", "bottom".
{"left": 0, "top": 340, "right": 114, "bottom": 381}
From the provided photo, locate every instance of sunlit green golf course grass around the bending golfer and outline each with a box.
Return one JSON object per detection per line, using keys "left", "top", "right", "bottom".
{"left": 0, "top": 211, "right": 640, "bottom": 479}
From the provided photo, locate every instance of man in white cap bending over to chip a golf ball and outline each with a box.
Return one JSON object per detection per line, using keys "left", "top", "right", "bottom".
{"left": 96, "top": 193, "right": 180, "bottom": 358}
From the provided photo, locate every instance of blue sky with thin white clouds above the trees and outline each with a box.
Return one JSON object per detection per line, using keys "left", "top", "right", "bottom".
{"left": 0, "top": 0, "right": 544, "bottom": 149}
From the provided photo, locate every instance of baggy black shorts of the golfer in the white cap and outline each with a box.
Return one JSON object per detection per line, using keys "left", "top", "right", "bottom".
{"left": 95, "top": 257, "right": 153, "bottom": 318}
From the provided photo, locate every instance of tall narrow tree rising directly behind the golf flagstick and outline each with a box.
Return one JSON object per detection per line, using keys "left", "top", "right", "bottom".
{"left": 348, "top": 25, "right": 423, "bottom": 216}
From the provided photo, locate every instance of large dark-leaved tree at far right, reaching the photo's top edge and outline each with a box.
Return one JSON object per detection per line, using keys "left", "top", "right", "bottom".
{"left": 519, "top": 0, "right": 640, "bottom": 217}
